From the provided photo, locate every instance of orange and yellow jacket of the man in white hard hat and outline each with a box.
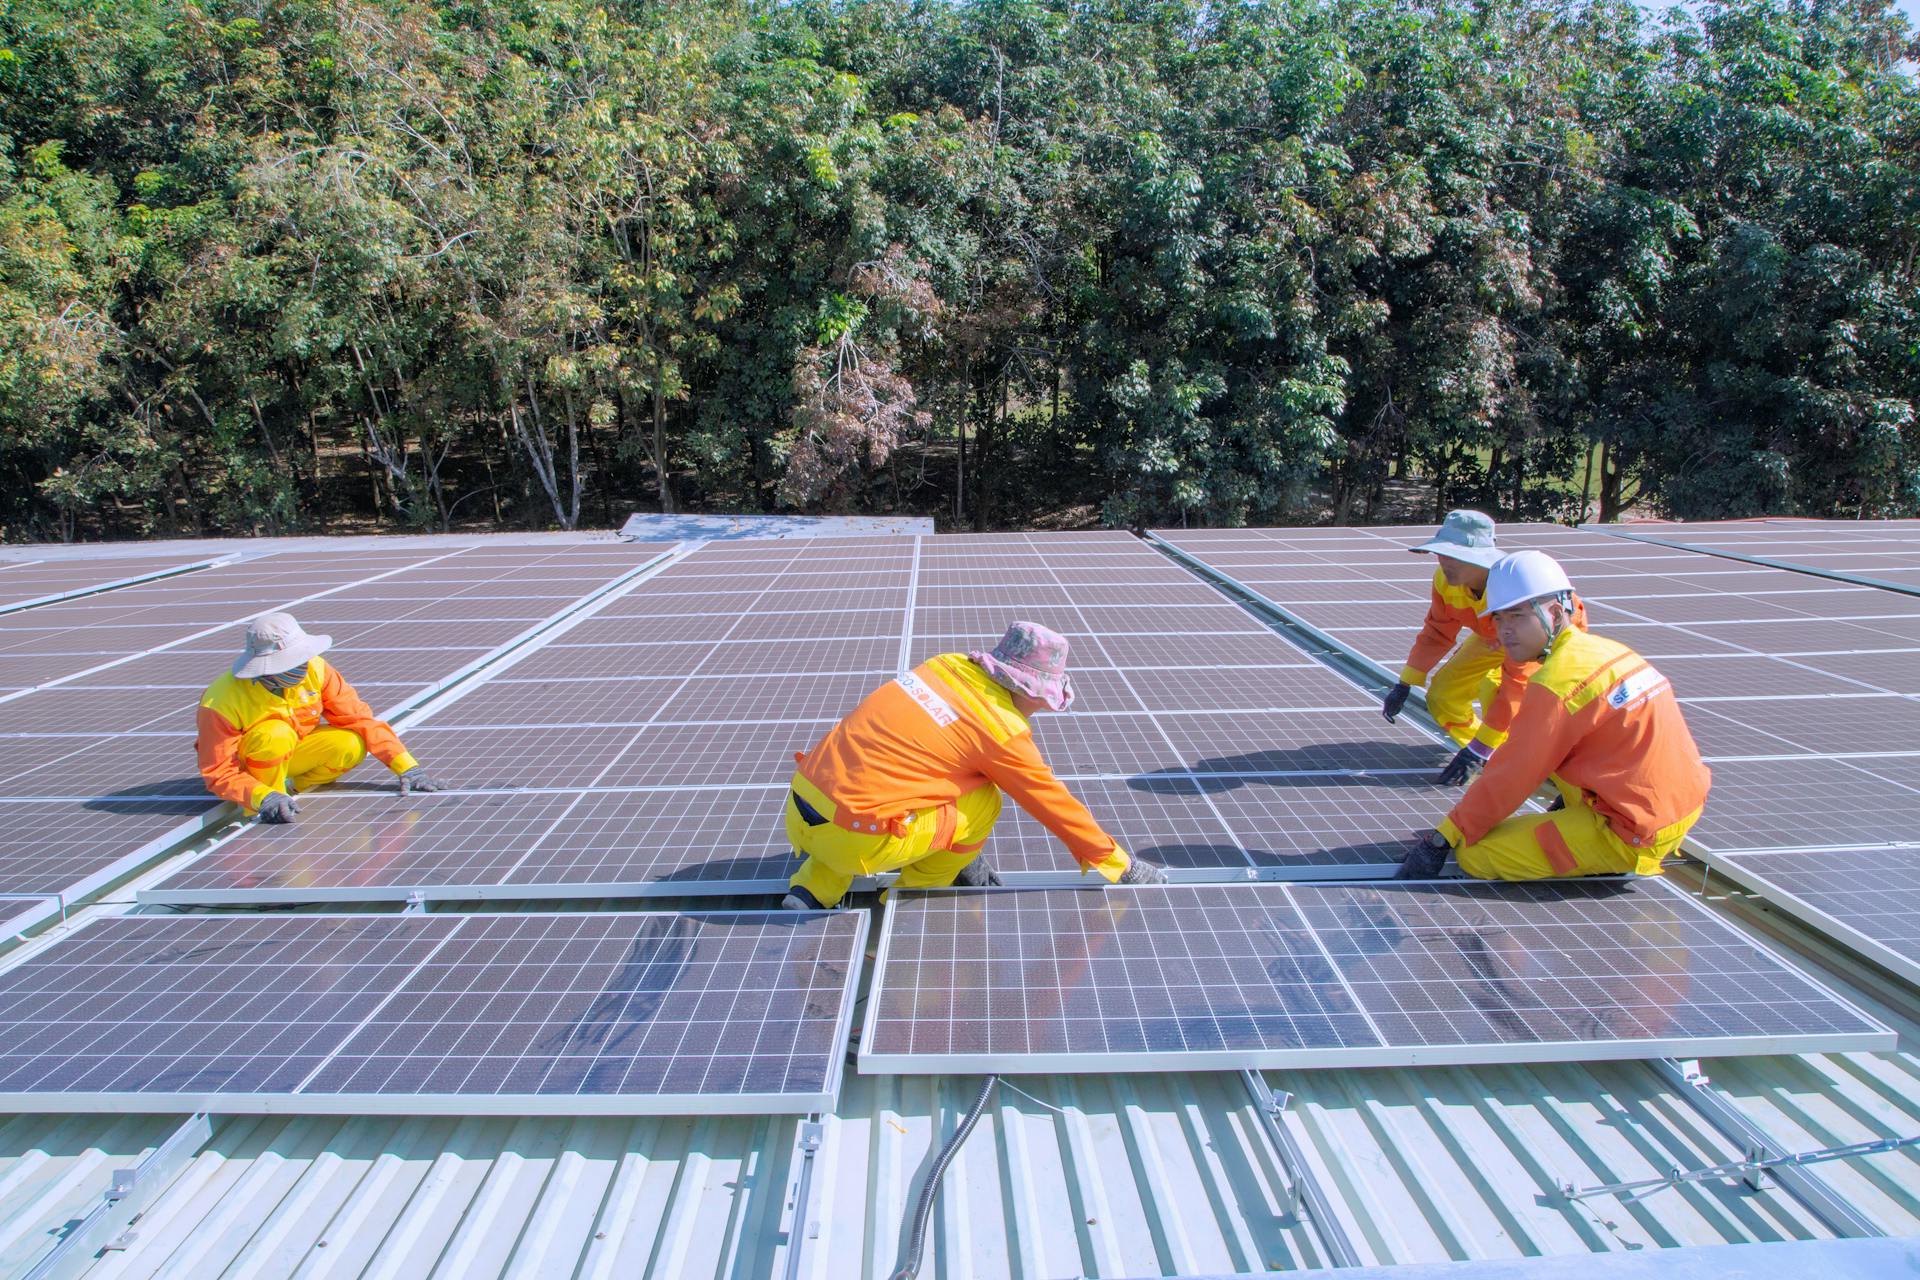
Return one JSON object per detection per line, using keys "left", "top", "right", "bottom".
{"left": 1440, "top": 628, "right": 1713, "bottom": 848}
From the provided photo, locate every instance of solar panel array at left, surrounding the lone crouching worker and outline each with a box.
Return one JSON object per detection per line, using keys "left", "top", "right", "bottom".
{"left": 0, "top": 545, "right": 662, "bottom": 898}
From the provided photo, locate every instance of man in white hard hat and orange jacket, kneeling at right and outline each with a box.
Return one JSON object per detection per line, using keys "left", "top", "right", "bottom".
{"left": 1396, "top": 551, "right": 1713, "bottom": 881}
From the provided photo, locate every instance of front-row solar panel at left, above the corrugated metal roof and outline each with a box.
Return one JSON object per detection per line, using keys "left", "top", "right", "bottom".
{"left": 0, "top": 912, "right": 866, "bottom": 1115}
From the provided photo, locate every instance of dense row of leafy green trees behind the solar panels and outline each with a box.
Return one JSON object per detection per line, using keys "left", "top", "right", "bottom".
{"left": 0, "top": 0, "right": 1920, "bottom": 537}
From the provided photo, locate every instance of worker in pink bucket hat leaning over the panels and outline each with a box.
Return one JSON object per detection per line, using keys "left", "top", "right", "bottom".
{"left": 781, "top": 622, "right": 1165, "bottom": 910}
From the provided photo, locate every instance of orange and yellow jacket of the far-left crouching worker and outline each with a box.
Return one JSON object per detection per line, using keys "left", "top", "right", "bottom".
{"left": 194, "top": 658, "right": 419, "bottom": 810}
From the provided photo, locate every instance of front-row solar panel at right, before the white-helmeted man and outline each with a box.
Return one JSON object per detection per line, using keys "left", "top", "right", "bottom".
{"left": 860, "top": 881, "right": 1895, "bottom": 1075}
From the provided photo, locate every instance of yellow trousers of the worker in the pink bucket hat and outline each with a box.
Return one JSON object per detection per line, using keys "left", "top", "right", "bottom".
{"left": 787, "top": 783, "right": 1000, "bottom": 906}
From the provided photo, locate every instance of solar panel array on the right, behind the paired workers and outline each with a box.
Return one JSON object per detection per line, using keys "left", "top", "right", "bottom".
{"left": 1158, "top": 526, "right": 1920, "bottom": 997}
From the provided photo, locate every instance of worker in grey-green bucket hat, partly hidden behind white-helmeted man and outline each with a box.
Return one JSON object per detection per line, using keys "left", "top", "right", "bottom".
{"left": 1380, "top": 510, "right": 1586, "bottom": 787}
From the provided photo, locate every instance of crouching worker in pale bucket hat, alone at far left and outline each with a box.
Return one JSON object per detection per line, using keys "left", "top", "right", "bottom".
{"left": 196, "top": 614, "right": 440, "bottom": 823}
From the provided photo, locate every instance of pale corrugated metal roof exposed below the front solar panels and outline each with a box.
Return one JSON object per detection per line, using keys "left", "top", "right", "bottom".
{"left": 15, "top": 1055, "right": 1920, "bottom": 1280}
